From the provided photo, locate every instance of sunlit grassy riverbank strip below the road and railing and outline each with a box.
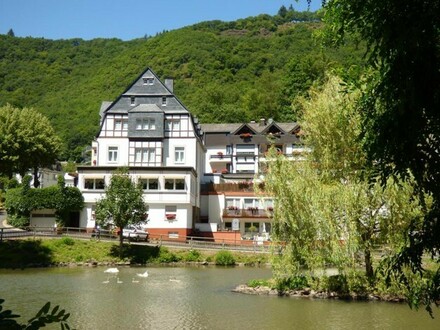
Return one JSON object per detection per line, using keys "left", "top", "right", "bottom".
{"left": 0, "top": 237, "right": 268, "bottom": 268}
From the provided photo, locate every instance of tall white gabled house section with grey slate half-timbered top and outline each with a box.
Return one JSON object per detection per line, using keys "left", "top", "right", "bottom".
{"left": 78, "top": 69, "right": 204, "bottom": 237}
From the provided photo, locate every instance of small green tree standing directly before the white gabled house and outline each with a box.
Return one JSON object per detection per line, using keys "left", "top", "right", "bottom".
{"left": 95, "top": 168, "right": 147, "bottom": 251}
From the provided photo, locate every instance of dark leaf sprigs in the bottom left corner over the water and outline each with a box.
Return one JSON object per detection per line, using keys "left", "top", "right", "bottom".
{"left": 0, "top": 299, "right": 70, "bottom": 330}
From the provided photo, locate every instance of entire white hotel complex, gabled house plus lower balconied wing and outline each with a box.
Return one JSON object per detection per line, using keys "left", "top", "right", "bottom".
{"left": 78, "top": 69, "right": 302, "bottom": 239}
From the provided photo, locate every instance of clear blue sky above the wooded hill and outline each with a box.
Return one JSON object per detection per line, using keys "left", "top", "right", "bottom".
{"left": 0, "top": 0, "right": 321, "bottom": 40}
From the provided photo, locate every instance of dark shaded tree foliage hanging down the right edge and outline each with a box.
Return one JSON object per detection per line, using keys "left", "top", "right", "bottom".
{"left": 325, "top": 0, "right": 440, "bottom": 311}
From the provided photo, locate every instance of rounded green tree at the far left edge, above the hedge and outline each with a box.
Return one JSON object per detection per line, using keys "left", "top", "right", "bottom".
{"left": 0, "top": 104, "right": 61, "bottom": 187}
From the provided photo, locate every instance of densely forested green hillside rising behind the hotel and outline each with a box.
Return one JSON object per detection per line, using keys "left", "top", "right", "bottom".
{"left": 0, "top": 10, "right": 363, "bottom": 160}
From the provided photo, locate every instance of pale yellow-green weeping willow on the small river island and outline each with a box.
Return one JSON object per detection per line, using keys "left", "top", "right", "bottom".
{"left": 265, "top": 77, "right": 428, "bottom": 280}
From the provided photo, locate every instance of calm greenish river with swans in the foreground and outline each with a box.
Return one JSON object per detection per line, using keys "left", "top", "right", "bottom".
{"left": 0, "top": 266, "right": 440, "bottom": 330}
